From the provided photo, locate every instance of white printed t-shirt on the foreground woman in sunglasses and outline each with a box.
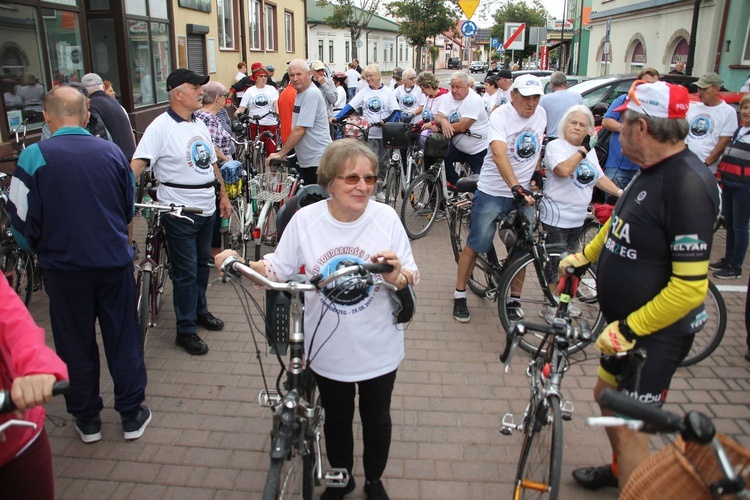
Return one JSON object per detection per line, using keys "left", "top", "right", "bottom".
{"left": 264, "top": 202, "right": 417, "bottom": 382}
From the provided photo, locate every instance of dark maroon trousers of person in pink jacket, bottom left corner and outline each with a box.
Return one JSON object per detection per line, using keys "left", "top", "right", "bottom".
{"left": 0, "top": 428, "right": 55, "bottom": 500}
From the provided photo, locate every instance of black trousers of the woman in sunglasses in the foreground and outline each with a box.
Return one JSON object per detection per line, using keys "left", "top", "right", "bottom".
{"left": 315, "top": 370, "right": 396, "bottom": 481}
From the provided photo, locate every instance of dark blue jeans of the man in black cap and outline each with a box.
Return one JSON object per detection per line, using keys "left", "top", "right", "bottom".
{"left": 162, "top": 213, "right": 218, "bottom": 335}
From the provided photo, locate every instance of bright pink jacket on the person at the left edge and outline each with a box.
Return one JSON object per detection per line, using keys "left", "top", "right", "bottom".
{"left": 0, "top": 276, "right": 68, "bottom": 467}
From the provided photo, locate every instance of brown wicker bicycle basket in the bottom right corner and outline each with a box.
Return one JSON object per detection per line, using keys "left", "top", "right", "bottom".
{"left": 620, "top": 434, "right": 750, "bottom": 500}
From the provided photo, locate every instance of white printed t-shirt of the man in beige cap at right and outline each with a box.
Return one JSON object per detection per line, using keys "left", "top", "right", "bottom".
{"left": 685, "top": 101, "right": 737, "bottom": 173}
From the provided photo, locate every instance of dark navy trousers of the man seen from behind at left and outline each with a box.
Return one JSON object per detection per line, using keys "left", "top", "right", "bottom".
{"left": 44, "top": 264, "right": 147, "bottom": 422}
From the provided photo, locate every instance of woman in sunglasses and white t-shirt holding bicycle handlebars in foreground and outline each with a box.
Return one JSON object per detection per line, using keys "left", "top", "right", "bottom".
{"left": 215, "top": 139, "right": 419, "bottom": 499}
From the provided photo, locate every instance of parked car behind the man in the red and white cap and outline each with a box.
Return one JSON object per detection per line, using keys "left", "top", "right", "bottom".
{"left": 570, "top": 74, "right": 743, "bottom": 125}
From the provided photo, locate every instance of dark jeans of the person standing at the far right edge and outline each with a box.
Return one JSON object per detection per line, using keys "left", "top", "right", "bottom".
{"left": 721, "top": 182, "right": 750, "bottom": 269}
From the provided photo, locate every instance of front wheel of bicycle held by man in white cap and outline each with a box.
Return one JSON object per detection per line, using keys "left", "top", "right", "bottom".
{"left": 497, "top": 244, "right": 604, "bottom": 354}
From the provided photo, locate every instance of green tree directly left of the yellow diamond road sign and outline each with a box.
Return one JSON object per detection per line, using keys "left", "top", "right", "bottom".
{"left": 386, "top": 0, "right": 459, "bottom": 71}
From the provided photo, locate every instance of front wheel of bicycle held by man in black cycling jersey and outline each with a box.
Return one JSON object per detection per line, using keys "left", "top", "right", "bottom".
{"left": 514, "top": 395, "right": 563, "bottom": 500}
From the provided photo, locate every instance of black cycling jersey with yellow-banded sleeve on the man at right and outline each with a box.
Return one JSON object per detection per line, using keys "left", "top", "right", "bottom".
{"left": 587, "top": 149, "right": 720, "bottom": 335}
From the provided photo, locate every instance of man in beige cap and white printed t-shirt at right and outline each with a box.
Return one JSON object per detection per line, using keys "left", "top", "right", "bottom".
{"left": 685, "top": 73, "right": 737, "bottom": 174}
